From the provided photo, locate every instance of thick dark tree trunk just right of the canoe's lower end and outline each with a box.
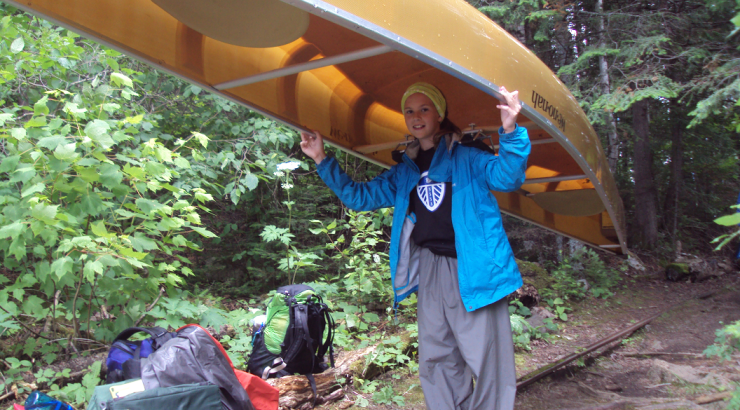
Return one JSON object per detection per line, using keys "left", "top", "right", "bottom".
{"left": 632, "top": 100, "right": 658, "bottom": 249}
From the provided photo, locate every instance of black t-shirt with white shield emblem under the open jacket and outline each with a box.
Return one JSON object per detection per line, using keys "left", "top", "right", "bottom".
{"left": 410, "top": 148, "right": 457, "bottom": 258}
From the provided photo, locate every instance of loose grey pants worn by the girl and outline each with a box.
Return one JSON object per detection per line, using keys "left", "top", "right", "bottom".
{"left": 418, "top": 249, "right": 516, "bottom": 410}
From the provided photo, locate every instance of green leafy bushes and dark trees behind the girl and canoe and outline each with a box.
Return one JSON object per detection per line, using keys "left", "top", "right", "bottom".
{"left": 0, "top": 0, "right": 740, "bottom": 402}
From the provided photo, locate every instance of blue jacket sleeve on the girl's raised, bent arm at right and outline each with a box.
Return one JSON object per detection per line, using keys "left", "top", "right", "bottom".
{"left": 472, "top": 125, "right": 532, "bottom": 192}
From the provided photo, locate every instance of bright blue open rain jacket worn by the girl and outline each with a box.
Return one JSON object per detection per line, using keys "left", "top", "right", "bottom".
{"left": 317, "top": 126, "right": 531, "bottom": 311}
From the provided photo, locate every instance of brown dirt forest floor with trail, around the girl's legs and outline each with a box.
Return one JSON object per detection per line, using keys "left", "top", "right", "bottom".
{"left": 321, "top": 264, "right": 740, "bottom": 410}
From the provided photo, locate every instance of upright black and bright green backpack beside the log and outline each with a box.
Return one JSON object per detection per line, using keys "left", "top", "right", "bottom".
{"left": 247, "top": 285, "right": 334, "bottom": 403}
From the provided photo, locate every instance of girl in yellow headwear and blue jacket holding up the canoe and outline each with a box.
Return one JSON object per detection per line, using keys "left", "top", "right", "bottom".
{"left": 301, "top": 83, "right": 530, "bottom": 410}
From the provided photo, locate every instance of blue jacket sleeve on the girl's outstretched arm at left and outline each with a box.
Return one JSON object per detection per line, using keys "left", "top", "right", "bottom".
{"left": 316, "top": 157, "right": 398, "bottom": 211}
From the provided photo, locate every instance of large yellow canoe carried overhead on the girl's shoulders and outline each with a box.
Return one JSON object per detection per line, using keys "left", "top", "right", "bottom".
{"left": 6, "top": 0, "right": 627, "bottom": 254}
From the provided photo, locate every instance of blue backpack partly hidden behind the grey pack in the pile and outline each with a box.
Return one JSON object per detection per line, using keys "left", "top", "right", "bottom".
{"left": 105, "top": 327, "right": 177, "bottom": 384}
